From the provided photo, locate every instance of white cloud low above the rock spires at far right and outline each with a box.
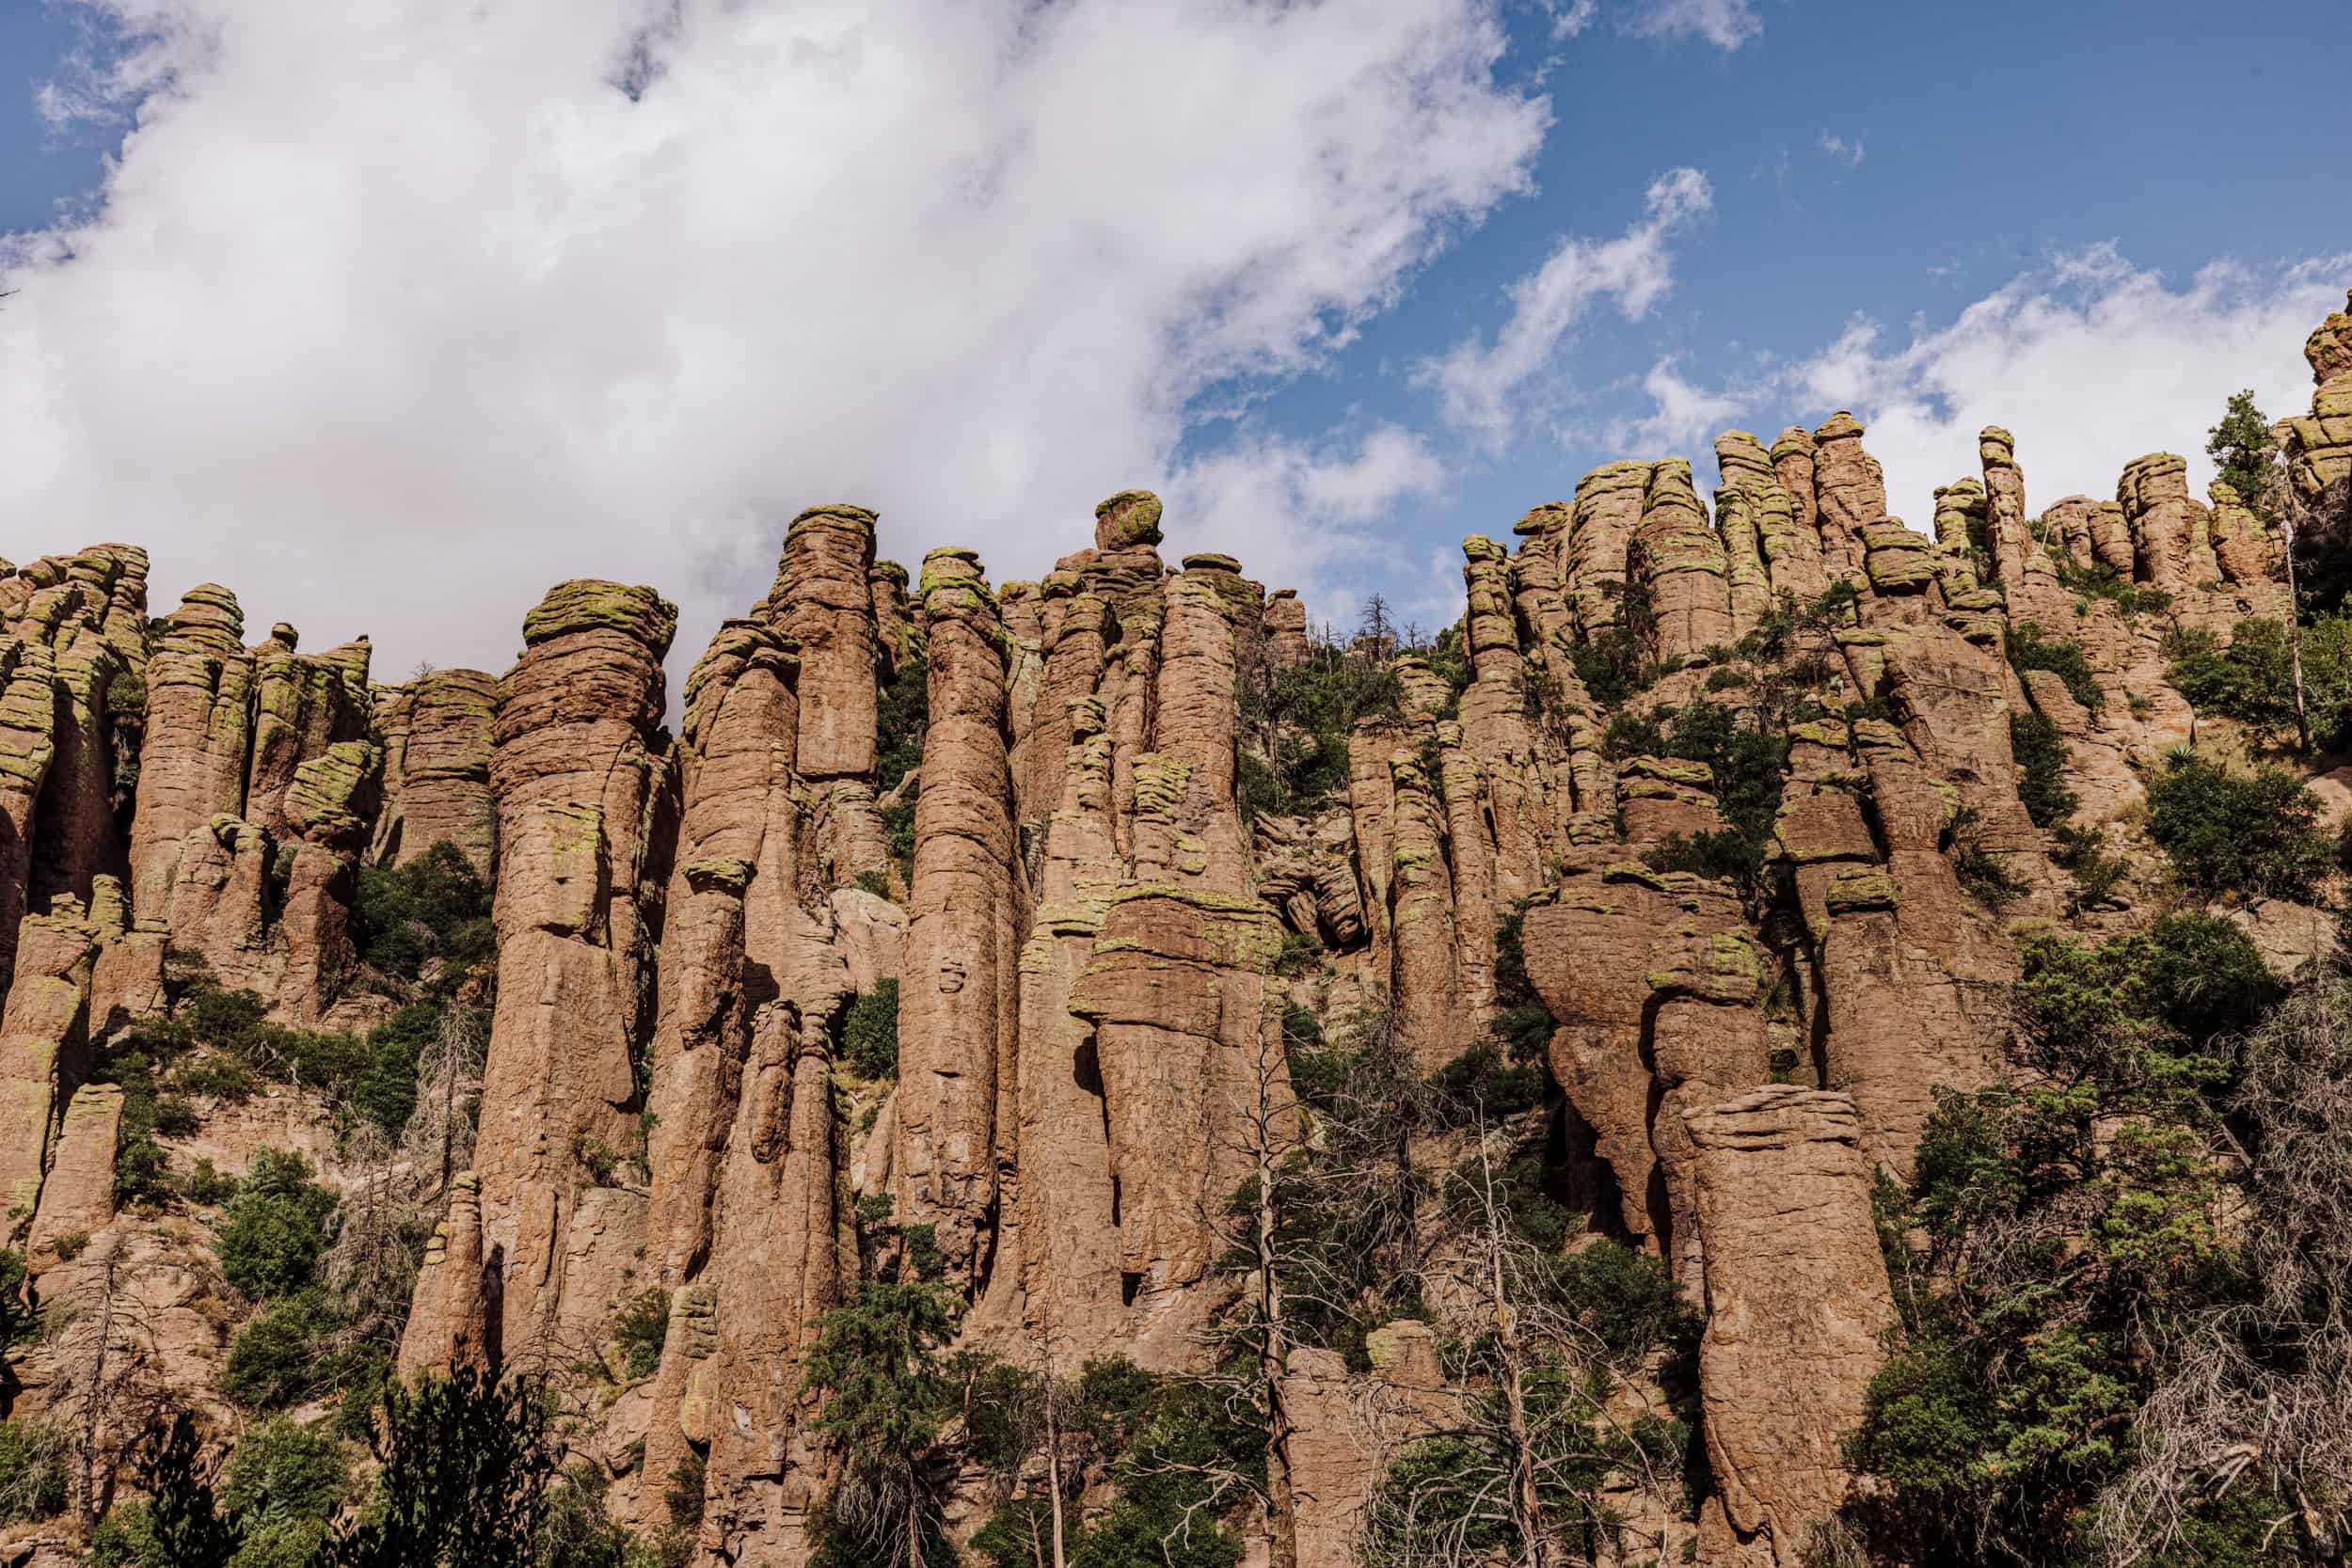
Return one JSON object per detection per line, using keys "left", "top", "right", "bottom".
{"left": 1783, "top": 245, "right": 2352, "bottom": 529}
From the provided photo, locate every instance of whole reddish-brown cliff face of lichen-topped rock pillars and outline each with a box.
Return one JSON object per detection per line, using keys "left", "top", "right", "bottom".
{"left": 0, "top": 297, "right": 2352, "bottom": 1568}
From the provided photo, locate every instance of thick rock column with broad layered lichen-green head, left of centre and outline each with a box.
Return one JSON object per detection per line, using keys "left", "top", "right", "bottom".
{"left": 475, "top": 580, "right": 677, "bottom": 1356}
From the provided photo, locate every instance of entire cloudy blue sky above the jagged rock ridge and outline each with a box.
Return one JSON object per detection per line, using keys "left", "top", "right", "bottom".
{"left": 0, "top": 0, "right": 2352, "bottom": 674}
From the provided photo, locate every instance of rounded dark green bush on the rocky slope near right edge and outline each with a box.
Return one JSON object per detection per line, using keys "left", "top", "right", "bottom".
{"left": 2148, "top": 750, "right": 2336, "bottom": 903}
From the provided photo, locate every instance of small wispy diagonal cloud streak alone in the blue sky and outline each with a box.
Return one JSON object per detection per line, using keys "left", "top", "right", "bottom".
{"left": 1416, "top": 169, "right": 1715, "bottom": 451}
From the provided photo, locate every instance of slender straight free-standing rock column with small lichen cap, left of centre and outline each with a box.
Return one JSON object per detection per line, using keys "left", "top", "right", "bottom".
{"left": 892, "top": 550, "right": 1019, "bottom": 1275}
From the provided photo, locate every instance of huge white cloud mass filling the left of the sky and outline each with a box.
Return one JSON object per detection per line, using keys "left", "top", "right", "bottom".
{"left": 0, "top": 0, "right": 1543, "bottom": 677}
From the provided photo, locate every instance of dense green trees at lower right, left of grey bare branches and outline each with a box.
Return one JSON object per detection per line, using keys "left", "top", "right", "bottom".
{"left": 1851, "top": 914, "right": 2280, "bottom": 1566}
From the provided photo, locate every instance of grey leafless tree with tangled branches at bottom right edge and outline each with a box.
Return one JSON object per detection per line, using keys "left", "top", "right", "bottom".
{"left": 2101, "top": 971, "right": 2352, "bottom": 1568}
